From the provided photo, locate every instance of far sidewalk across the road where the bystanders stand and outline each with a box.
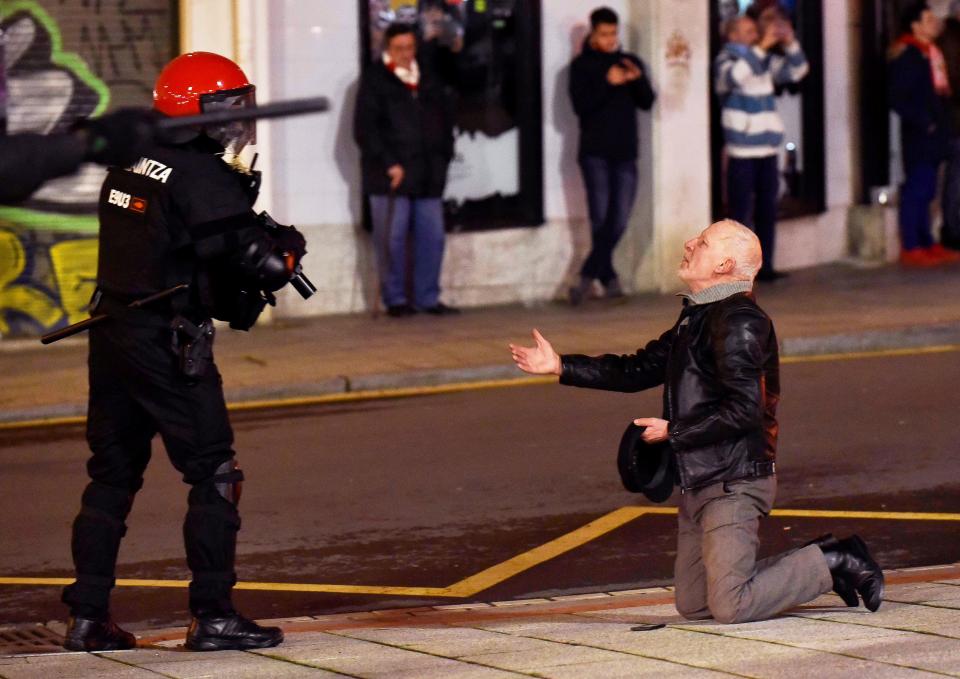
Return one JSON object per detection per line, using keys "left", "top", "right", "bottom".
{"left": 0, "top": 265, "right": 960, "bottom": 422}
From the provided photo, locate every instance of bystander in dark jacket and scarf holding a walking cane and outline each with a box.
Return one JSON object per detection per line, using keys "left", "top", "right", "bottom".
{"left": 354, "top": 23, "right": 457, "bottom": 317}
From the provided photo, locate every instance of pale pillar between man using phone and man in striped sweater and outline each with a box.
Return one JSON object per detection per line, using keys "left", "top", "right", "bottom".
{"left": 618, "top": 0, "right": 711, "bottom": 292}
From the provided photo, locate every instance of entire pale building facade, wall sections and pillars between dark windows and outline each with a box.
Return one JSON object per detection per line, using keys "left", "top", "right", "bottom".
{"left": 183, "top": 0, "right": 864, "bottom": 315}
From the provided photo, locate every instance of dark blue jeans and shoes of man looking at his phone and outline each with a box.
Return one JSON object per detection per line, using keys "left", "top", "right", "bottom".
{"left": 580, "top": 156, "right": 637, "bottom": 285}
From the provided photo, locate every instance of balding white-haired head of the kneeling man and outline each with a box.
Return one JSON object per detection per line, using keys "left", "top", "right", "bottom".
{"left": 678, "top": 219, "right": 762, "bottom": 292}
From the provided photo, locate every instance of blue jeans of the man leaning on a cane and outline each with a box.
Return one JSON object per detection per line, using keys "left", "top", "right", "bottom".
{"left": 370, "top": 195, "right": 445, "bottom": 309}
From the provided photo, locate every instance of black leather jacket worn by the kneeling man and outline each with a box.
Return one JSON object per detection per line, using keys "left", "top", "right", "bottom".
{"left": 560, "top": 293, "right": 780, "bottom": 489}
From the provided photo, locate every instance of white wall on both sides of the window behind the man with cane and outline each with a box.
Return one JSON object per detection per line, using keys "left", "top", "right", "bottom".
{"left": 228, "top": 0, "right": 629, "bottom": 315}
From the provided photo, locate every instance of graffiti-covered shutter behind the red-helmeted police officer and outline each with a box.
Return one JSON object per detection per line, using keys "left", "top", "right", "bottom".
{"left": 0, "top": 0, "right": 174, "bottom": 337}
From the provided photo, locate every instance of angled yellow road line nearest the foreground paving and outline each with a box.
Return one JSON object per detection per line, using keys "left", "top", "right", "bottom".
{"left": 0, "top": 506, "right": 960, "bottom": 599}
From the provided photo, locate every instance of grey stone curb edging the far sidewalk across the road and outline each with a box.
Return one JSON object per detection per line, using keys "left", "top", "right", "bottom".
{"left": 0, "top": 323, "right": 960, "bottom": 430}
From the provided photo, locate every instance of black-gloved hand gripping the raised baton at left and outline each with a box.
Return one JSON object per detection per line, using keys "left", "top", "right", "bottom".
{"left": 74, "top": 108, "right": 157, "bottom": 167}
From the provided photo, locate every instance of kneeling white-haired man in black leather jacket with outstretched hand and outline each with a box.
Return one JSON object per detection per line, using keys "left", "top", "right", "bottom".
{"left": 511, "top": 220, "right": 883, "bottom": 623}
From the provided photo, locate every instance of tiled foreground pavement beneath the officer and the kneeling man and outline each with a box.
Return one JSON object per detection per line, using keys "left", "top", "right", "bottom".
{"left": 0, "top": 564, "right": 960, "bottom": 679}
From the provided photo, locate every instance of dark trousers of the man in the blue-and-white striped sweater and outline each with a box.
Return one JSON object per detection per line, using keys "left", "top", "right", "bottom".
{"left": 727, "top": 156, "right": 780, "bottom": 271}
